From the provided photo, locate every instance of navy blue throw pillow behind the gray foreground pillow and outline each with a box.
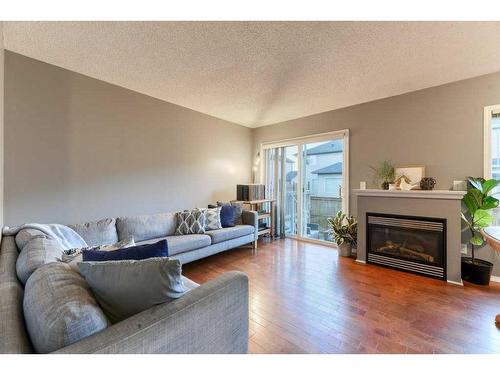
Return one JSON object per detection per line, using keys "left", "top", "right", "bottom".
{"left": 82, "top": 240, "right": 168, "bottom": 262}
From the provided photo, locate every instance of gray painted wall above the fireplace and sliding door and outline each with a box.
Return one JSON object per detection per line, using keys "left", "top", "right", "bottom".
{"left": 253, "top": 73, "right": 500, "bottom": 276}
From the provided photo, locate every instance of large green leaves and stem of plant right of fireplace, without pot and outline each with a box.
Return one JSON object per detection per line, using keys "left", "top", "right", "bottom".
{"left": 461, "top": 177, "right": 500, "bottom": 263}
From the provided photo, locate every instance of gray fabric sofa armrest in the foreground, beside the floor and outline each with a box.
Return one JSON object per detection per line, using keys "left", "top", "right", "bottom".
{"left": 55, "top": 271, "right": 248, "bottom": 354}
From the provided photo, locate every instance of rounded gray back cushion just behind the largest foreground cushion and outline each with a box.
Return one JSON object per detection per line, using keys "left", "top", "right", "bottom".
{"left": 16, "top": 237, "right": 63, "bottom": 284}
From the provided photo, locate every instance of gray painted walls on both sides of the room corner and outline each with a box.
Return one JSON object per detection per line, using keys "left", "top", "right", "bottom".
{"left": 4, "top": 51, "right": 500, "bottom": 275}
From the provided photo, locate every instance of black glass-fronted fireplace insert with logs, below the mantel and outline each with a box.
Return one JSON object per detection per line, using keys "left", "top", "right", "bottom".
{"left": 366, "top": 212, "right": 446, "bottom": 280}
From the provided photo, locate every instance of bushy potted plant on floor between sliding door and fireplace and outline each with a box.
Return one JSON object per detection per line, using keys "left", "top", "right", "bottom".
{"left": 328, "top": 211, "right": 358, "bottom": 257}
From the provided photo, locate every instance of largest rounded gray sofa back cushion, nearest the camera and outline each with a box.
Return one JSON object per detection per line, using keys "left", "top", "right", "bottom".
{"left": 23, "top": 262, "right": 109, "bottom": 353}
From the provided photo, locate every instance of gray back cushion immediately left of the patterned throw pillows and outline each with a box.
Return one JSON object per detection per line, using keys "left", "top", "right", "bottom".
{"left": 116, "top": 213, "right": 176, "bottom": 242}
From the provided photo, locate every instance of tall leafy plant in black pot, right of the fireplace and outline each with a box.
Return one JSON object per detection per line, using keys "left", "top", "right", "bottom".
{"left": 462, "top": 177, "right": 500, "bottom": 285}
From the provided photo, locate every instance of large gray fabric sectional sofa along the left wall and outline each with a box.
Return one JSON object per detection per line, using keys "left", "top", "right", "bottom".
{"left": 0, "top": 211, "right": 258, "bottom": 353}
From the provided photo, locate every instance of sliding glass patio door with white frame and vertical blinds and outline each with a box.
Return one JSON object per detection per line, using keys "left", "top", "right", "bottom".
{"left": 262, "top": 130, "right": 349, "bottom": 245}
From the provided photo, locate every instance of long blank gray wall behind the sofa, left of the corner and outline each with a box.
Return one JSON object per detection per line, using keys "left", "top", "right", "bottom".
{"left": 5, "top": 51, "right": 252, "bottom": 225}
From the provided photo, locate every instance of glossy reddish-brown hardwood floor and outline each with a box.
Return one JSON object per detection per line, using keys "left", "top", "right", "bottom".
{"left": 183, "top": 239, "right": 500, "bottom": 353}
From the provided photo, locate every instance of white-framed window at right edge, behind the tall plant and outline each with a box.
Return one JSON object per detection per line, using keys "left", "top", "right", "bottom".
{"left": 483, "top": 105, "right": 500, "bottom": 225}
